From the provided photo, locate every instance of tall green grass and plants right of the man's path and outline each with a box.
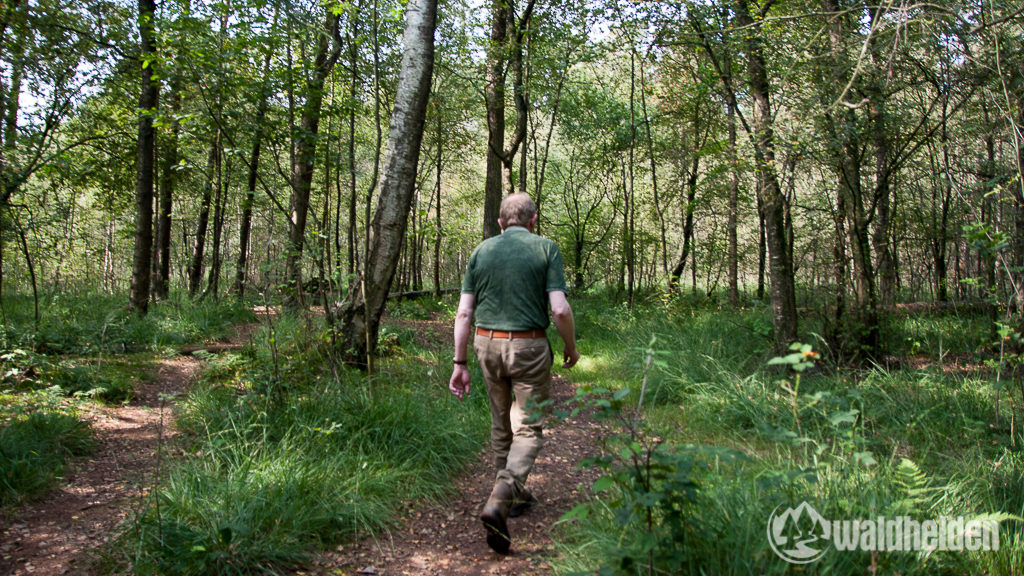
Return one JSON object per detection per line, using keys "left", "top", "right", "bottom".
{"left": 557, "top": 293, "right": 1024, "bottom": 575}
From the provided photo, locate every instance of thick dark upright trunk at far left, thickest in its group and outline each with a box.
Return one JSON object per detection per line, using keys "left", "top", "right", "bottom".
{"left": 129, "top": 0, "right": 160, "bottom": 316}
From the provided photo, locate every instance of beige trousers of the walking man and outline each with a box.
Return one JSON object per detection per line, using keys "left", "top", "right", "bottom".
{"left": 473, "top": 334, "right": 552, "bottom": 495}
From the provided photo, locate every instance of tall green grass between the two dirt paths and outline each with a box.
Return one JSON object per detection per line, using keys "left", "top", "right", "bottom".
{"left": 111, "top": 306, "right": 487, "bottom": 575}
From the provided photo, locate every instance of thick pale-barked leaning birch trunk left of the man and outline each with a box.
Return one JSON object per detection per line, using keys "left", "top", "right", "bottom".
{"left": 340, "top": 0, "right": 437, "bottom": 369}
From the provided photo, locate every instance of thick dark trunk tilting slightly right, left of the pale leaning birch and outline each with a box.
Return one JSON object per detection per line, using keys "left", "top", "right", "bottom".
{"left": 284, "top": 8, "right": 341, "bottom": 307}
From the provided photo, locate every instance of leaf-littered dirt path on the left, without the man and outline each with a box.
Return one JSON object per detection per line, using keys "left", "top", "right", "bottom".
{"left": 0, "top": 325, "right": 256, "bottom": 576}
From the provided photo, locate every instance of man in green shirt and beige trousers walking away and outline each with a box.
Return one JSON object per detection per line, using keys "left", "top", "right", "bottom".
{"left": 449, "top": 194, "right": 580, "bottom": 554}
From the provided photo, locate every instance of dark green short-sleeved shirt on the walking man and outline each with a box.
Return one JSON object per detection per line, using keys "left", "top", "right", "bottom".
{"left": 462, "top": 227, "right": 567, "bottom": 330}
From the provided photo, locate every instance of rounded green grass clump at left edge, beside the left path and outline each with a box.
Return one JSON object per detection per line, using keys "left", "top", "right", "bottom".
{"left": 0, "top": 388, "right": 94, "bottom": 505}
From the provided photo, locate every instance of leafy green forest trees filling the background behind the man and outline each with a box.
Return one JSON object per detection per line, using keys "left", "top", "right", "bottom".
{"left": 0, "top": 0, "right": 1024, "bottom": 358}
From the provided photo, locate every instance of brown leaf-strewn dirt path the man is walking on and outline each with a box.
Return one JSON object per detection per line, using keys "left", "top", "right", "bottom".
{"left": 307, "top": 376, "right": 605, "bottom": 576}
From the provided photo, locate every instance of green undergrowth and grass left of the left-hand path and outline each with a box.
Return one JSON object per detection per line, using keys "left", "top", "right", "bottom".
{"left": 0, "top": 292, "right": 252, "bottom": 506}
